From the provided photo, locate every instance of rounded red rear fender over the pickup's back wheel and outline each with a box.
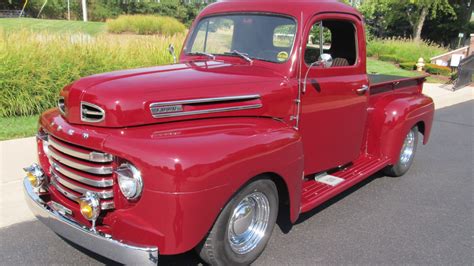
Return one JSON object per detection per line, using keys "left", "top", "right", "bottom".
{"left": 368, "top": 94, "right": 434, "bottom": 164}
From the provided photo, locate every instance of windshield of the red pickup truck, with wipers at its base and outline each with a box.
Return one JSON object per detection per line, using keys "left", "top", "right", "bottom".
{"left": 185, "top": 14, "right": 296, "bottom": 63}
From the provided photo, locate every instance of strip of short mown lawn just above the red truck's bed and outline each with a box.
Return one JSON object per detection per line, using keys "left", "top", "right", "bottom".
{"left": 367, "top": 58, "right": 446, "bottom": 83}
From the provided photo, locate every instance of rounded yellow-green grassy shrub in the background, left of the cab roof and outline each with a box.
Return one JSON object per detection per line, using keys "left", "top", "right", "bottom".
{"left": 107, "top": 15, "right": 186, "bottom": 36}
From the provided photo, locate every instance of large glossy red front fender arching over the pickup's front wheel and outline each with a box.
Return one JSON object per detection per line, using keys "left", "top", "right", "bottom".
{"left": 104, "top": 118, "right": 303, "bottom": 254}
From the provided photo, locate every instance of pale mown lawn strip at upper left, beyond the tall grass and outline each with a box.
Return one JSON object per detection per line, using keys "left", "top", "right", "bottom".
{"left": 0, "top": 18, "right": 106, "bottom": 35}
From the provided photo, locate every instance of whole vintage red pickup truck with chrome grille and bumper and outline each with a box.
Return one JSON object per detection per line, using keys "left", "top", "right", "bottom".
{"left": 24, "top": 0, "right": 434, "bottom": 265}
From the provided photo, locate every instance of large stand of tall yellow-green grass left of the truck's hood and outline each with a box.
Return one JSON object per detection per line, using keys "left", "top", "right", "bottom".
{"left": 0, "top": 30, "right": 185, "bottom": 117}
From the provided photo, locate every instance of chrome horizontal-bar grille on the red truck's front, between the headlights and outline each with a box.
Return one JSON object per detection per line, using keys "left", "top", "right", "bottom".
{"left": 48, "top": 135, "right": 115, "bottom": 210}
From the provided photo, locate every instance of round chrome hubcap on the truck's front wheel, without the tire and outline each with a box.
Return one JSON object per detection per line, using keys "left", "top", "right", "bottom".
{"left": 228, "top": 192, "right": 270, "bottom": 254}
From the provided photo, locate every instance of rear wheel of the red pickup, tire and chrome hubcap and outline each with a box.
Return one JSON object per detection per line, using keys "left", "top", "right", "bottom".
{"left": 384, "top": 126, "right": 418, "bottom": 177}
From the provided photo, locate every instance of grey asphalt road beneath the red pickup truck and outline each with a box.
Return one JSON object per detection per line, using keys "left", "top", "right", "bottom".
{"left": 0, "top": 101, "right": 474, "bottom": 265}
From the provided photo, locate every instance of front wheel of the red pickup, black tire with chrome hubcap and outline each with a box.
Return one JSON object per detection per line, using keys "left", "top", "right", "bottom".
{"left": 197, "top": 179, "right": 278, "bottom": 265}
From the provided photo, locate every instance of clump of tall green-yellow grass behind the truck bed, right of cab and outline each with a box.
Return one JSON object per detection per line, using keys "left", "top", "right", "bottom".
{"left": 367, "top": 38, "right": 448, "bottom": 63}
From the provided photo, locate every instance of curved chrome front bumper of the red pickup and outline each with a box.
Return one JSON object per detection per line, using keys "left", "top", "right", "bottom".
{"left": 23, "top": 178, "right": 158, "bottom": 265}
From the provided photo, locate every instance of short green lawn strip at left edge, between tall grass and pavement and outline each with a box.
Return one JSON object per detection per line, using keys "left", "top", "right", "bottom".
{"left": 0, "top": 116, "right": 38, "bottom": 140}
